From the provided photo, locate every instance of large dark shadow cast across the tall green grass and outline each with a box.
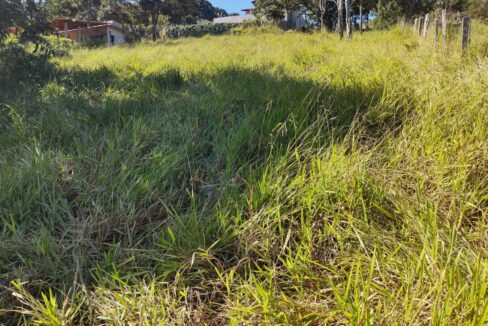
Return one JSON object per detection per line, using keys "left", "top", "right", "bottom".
{"left": 0, "top": 63, "right": 412, "bottom": 324}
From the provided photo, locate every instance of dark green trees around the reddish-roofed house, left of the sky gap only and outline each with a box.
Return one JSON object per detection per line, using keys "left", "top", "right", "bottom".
{"left": 0, "top": 0, "right": 228, "bottom": 41}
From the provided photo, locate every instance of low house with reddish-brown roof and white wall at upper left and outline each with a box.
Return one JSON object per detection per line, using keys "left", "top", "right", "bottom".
{"left": 51, "top": 18, "right": 125, "bottom": 45}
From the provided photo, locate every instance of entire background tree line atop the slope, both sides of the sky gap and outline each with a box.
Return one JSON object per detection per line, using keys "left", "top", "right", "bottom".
{"left": 0, "top": 0, "right": 488, "bottom": 44}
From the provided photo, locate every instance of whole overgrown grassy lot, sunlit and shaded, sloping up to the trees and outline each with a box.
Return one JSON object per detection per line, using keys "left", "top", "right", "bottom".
{"left": 0, "top": 24, "right": 488, "bottom": 325}
